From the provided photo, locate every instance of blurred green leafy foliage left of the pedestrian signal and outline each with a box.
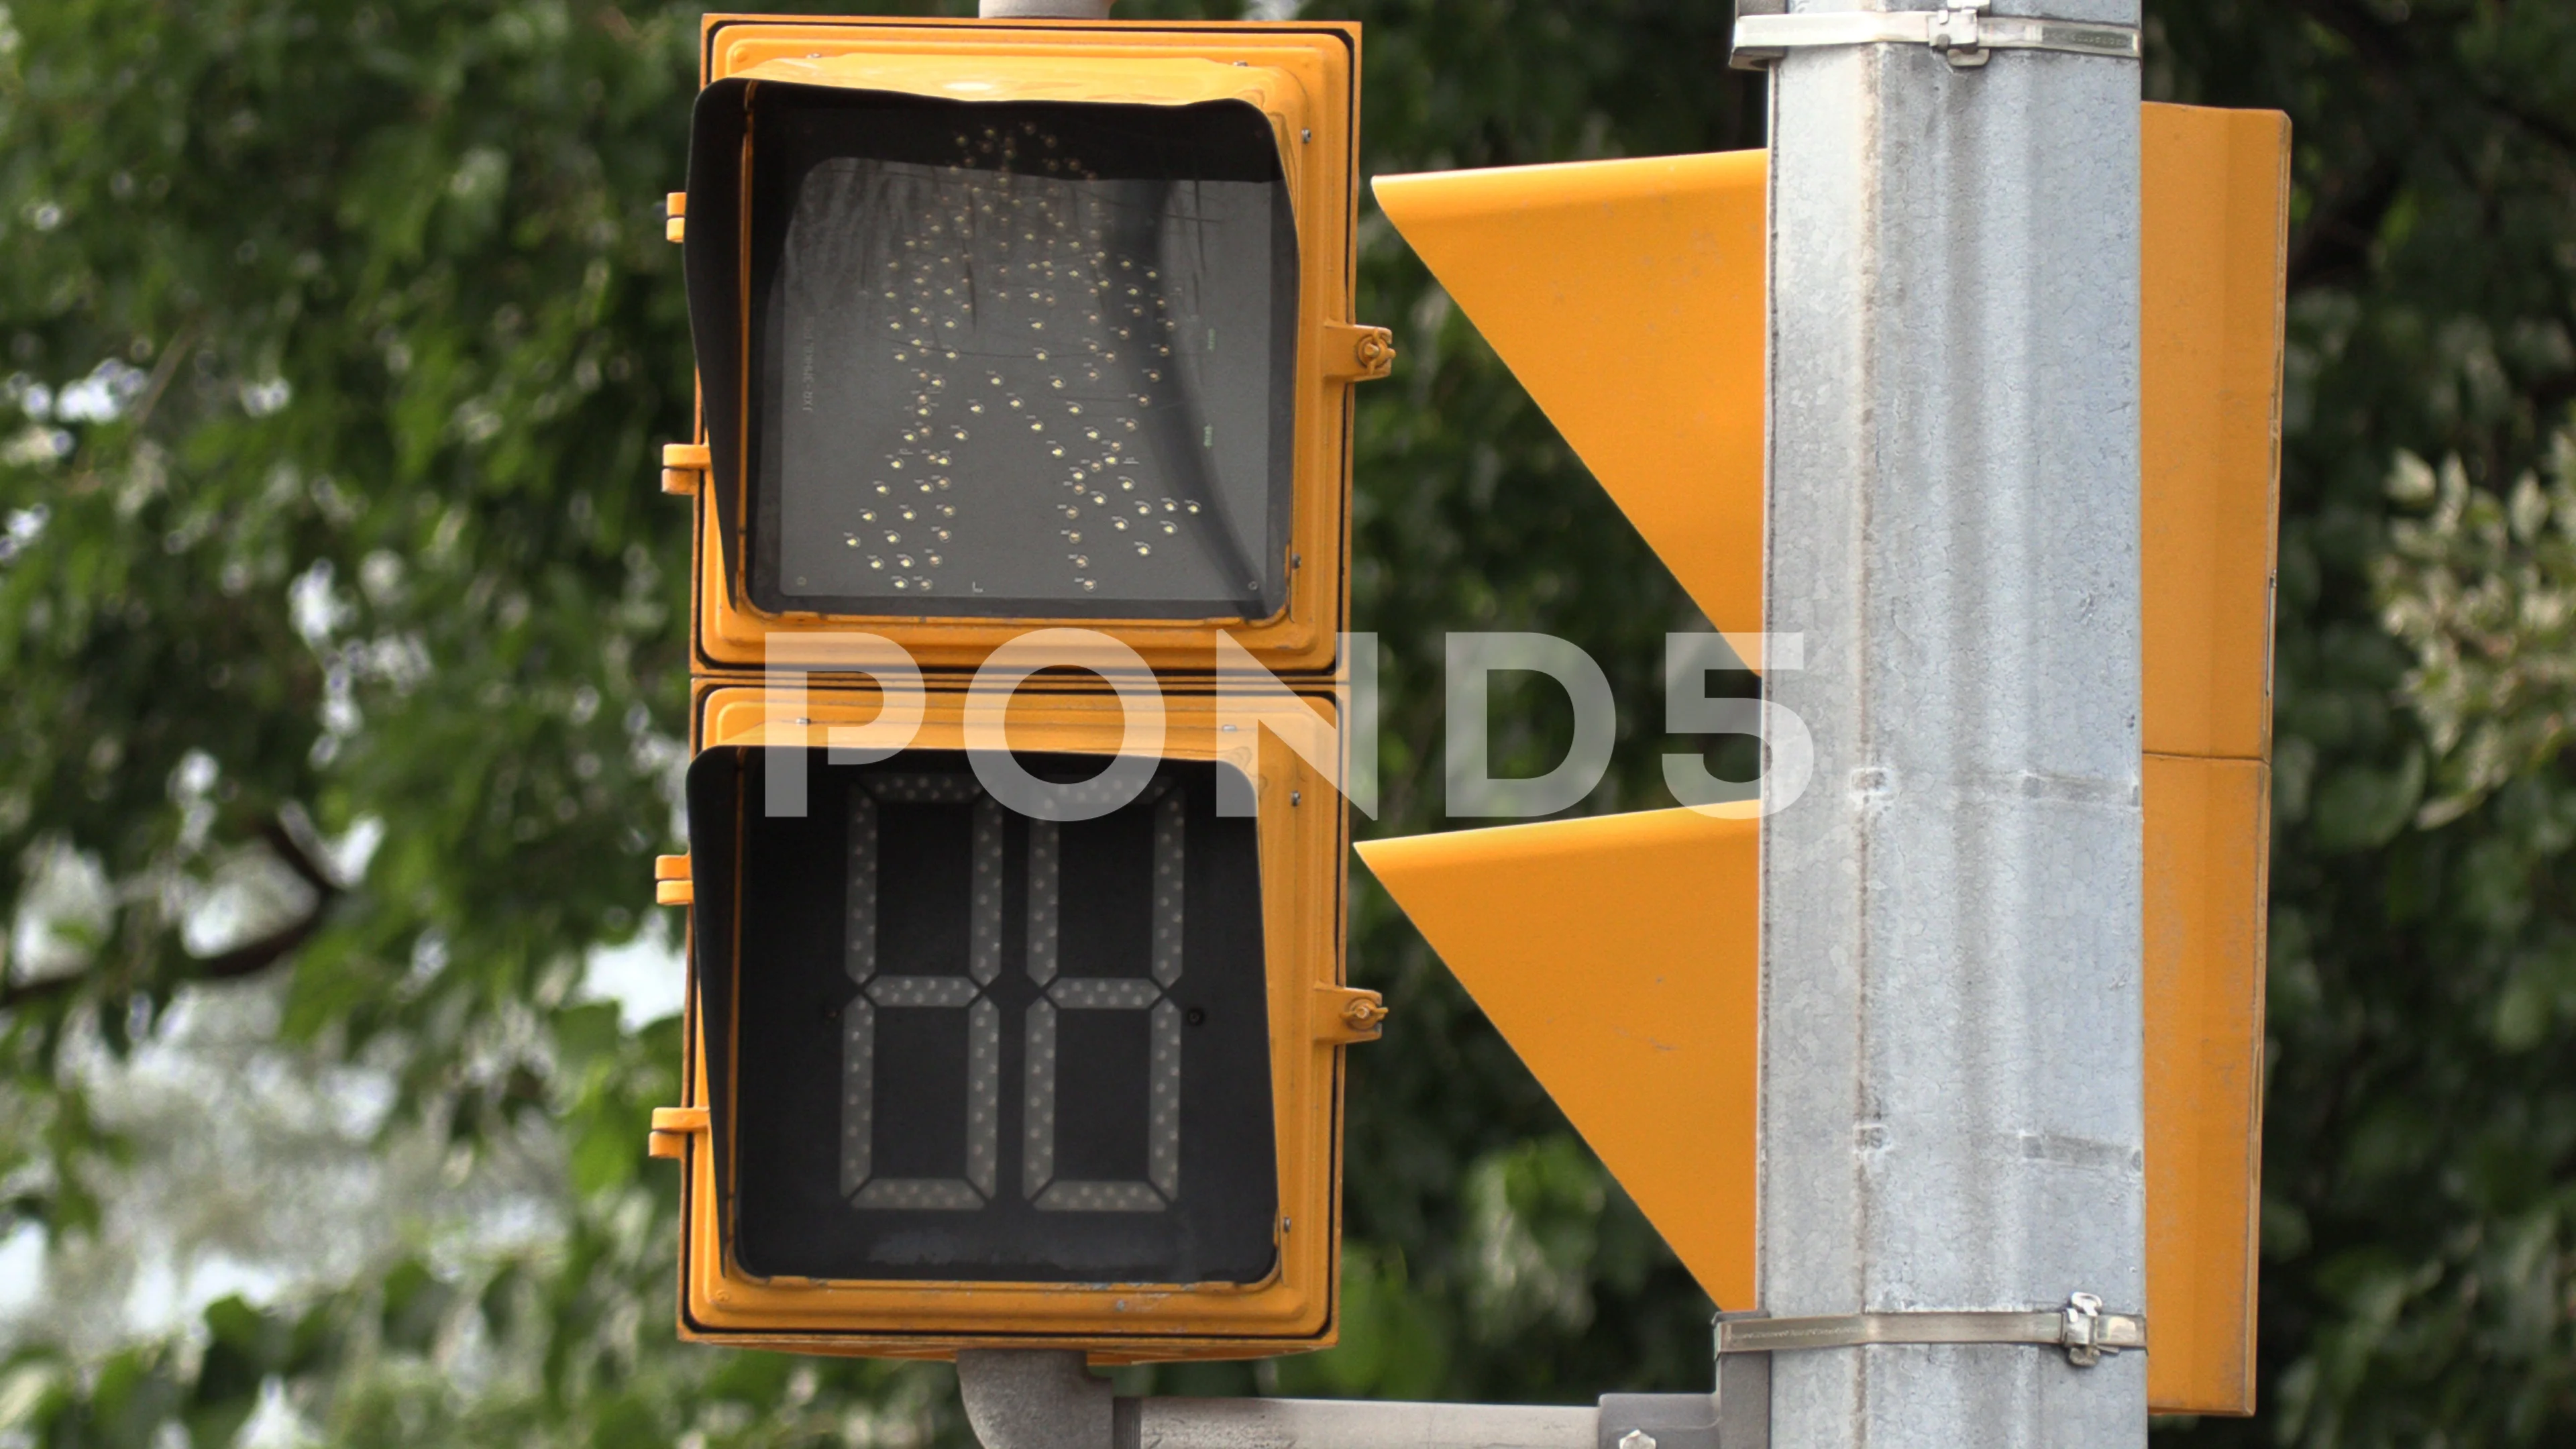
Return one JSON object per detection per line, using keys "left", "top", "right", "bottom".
{"left": 0, "top": 0, "right": 935, "bottom": 1444}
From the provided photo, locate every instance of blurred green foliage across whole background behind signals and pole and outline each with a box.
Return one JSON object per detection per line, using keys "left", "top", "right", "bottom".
{"left": 0, "top": 0, "right": 2576, "bottom": 1449}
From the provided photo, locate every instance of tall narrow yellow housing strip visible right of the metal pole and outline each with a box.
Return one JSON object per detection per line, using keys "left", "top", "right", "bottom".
{"left": 2138, "top": 106, "right": 2290, "bottom": 1413}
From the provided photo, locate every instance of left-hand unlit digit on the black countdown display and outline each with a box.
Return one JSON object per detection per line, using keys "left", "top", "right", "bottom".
{"left": 840, "top": 776, "right": 1002, "bottom": 1210}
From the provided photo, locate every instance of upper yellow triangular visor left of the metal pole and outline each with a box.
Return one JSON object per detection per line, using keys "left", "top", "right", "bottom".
{"left": 1371, "top": 152, "right": 1770, "bottom": 649}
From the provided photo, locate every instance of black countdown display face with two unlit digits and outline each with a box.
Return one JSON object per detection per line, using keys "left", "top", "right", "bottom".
{"left": 732, "top": 750, "right": 1278, "bottom": 1284}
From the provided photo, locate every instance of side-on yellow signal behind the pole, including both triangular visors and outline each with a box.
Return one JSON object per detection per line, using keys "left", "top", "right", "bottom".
{"left": 1362, "top": 106, "right": 2290, "bottom": 1413}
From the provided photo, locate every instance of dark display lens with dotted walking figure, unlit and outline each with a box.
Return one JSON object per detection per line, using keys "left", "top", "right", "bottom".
{"left": 752, "top": 91, "right": 1298, "bottom": 619}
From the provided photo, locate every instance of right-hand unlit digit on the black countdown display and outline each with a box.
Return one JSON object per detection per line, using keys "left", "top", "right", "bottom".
{"left": 1020, "top": 789, "right": 1185, "bottom": 1212}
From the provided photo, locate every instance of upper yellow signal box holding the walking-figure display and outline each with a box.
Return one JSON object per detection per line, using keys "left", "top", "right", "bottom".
{"left": 680, "top": 15, "right": 1391, "bottom": 673}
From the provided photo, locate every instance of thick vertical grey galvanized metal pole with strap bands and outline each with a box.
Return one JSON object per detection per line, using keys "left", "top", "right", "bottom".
{"left": 1762, "top": 0, "right": 2153, "bottom": 1449}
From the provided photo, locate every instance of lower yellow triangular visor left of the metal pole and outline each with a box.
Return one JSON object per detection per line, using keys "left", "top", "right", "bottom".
{"left": 1360, "top": 810, "right": 1762, "bottom": 1307}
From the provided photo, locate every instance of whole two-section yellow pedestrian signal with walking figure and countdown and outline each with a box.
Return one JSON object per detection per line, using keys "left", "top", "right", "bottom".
{"left": 652, "top": 15, "right": 1393, "bottom": 1361}
